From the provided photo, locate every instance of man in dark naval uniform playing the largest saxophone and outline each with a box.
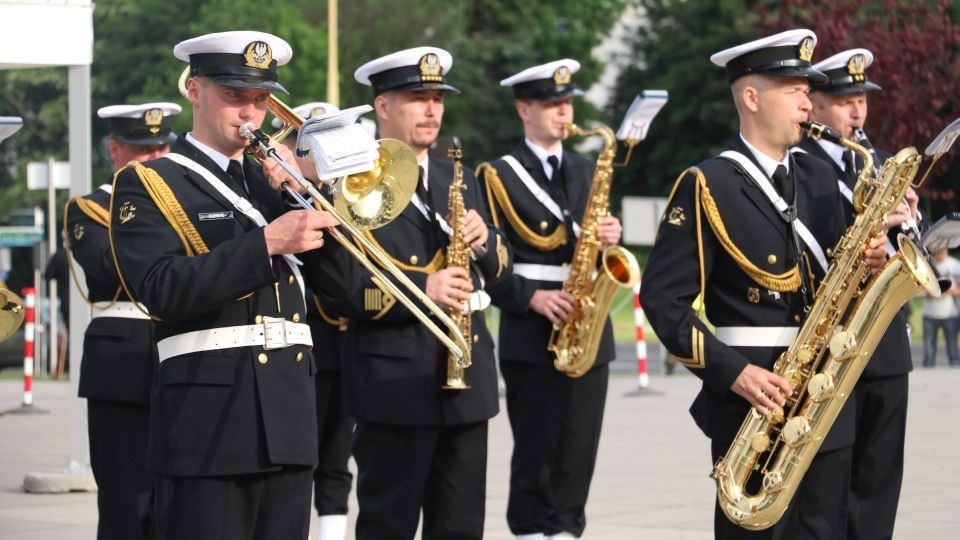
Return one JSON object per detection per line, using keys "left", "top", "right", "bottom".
{"left": 641, "top": 30, "right": 885, "bottom": 539}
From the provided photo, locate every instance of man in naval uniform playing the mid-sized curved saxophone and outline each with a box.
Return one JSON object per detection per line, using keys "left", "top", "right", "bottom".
{"left": 478, "top": 59, "right": 621, "bottom": 538}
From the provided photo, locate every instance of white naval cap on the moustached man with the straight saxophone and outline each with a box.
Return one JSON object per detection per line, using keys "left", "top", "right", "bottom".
{"left": 353, "top": 47, "right": 460, "bottom": 96}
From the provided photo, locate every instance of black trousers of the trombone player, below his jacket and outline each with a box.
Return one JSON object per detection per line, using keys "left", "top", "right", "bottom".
{"left": 156, "top": 467, "right": 313, "bottom": 540}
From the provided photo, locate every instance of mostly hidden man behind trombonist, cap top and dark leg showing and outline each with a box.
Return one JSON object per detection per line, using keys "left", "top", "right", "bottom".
{"left": 270, "top": 101, "right": 355, "bottom": 540}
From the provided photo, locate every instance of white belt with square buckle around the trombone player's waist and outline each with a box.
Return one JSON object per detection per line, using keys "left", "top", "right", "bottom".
{"left": 157, "top": 317, "right": 313, "bottom": 362}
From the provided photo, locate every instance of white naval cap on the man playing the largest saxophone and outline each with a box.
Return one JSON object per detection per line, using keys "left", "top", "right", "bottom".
{"left": 710, "top": 29, "right": 827, "bottom": 84}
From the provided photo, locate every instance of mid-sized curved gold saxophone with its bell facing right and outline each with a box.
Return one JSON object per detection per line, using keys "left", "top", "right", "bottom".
{"left": 547, "top": 124, "right": 640, "bottom": 378}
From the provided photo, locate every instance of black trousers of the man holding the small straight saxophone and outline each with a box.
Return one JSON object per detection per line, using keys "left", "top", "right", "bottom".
{"left": 353, "top": 421, "right": 487, "bottom": 540}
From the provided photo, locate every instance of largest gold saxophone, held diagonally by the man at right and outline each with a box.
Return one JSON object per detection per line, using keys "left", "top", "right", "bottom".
{"left": 711, "top": 123, "right": 940, "bottom": 530}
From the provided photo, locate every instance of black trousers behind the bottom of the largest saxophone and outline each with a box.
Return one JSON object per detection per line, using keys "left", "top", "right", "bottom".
{"left": 710, "top": 441, "right": 853, "bottom": 540}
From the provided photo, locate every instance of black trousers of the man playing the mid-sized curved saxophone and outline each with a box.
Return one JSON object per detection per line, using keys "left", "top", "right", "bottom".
{"left": 500, "top": 362, "right": 610, "bottom": 536}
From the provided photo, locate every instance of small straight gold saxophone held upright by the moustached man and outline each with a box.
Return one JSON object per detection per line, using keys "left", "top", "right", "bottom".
{"left": 443, "top": 138, "right": 473, "bottom": 390}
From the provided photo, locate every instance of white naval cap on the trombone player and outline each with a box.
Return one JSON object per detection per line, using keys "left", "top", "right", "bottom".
{"left": 173, "top": 30, "right": 293, "bottom": 93}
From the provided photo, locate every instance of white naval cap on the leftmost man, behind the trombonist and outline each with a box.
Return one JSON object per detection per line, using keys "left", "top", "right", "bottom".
{"left": 97, "top": 102, "right": 182, "bottom": 146}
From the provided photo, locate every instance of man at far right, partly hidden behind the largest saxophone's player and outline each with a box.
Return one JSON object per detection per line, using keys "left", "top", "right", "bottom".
{"left": 795, "top": 49, "right": 921, "bottom": 539}
